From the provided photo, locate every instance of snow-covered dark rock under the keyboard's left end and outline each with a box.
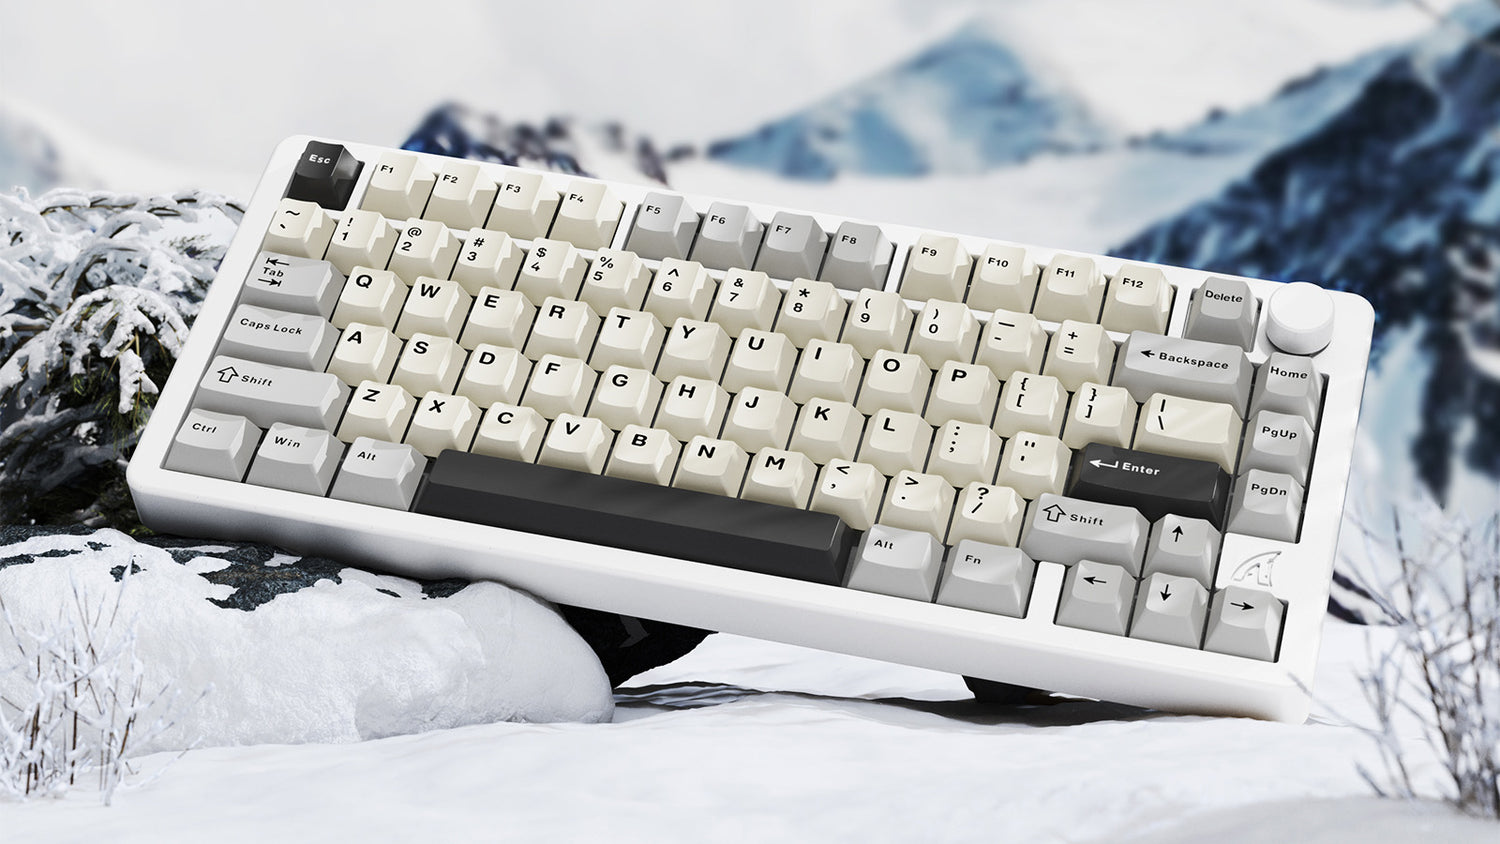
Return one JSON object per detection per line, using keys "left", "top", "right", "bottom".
{"left": 0, "top": 528, "right": 614, "bottom": 753}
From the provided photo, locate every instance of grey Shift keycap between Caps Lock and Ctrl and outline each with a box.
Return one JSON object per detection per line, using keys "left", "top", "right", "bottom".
{"left": 198, "top": 355, "right": 350, "bottom": 430}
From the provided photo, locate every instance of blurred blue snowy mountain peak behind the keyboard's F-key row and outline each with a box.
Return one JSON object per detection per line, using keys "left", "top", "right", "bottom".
{"left": 707, "top": 25, "right": 1112, "bottom": 178}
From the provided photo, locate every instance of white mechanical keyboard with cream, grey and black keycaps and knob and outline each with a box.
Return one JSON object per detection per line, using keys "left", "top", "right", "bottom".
{"left": 129, "top": 138, "right": 1374, "bottom": 721}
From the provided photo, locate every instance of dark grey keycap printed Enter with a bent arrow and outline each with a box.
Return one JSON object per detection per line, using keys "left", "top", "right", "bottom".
{"left": 1067, "top": 442, "right": 1230, "bottom": 529}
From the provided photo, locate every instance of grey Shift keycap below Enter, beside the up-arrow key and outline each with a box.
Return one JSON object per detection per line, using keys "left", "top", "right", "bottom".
{"left": 1022, "top": 492, "right": 1151, "bottom": 577}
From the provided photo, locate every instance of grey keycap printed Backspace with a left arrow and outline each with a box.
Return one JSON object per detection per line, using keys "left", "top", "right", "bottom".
{"left": 1113, "top": 331, "right": 1254, "bottom": 418}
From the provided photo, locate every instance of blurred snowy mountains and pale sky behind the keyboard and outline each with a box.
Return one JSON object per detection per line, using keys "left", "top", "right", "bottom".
{"left": 0, "top": 0, "right": 1500, "bottom": 593}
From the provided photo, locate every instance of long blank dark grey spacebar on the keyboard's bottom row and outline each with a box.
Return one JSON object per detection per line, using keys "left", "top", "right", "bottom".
{"left": 411, "top": 451, "right": 858, "bottom": 586}
